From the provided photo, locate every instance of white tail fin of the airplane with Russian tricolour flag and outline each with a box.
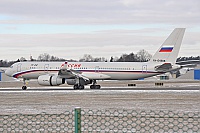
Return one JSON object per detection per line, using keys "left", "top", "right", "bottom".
{"left": 150, "top": 28, "right": 185, "bottom": 64}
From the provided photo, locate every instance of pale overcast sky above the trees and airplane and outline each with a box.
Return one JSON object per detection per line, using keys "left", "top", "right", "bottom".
{"left": 0, "top": 0, "right": 200, "bottom": 60}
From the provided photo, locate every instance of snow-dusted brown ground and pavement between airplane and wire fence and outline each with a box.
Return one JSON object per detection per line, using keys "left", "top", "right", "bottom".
{"left": 0, "top": 81, "right": 200, "bottom": 114}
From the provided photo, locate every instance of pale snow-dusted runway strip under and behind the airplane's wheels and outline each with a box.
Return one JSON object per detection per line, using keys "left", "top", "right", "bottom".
{"left": 0, "top": 80, "right": 200, "bottom": 91}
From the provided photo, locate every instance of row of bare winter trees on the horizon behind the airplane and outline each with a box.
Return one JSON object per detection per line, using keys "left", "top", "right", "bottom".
{"left": 0, "top": 49, "right": 200, "bottom": 67}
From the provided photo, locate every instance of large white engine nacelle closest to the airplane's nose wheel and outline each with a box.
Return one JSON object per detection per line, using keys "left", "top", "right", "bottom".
{"left": 38, "top": 75, "right": 65, "bottom": 86}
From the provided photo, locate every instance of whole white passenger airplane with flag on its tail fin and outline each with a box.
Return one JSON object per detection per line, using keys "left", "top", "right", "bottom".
{"left": 5, "top": 28, "right": 185, "bottom": 90}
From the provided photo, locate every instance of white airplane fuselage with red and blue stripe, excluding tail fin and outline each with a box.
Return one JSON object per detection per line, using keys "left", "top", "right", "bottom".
{"left": 6, "top": 62, "right": 161, "bottom": 80}
